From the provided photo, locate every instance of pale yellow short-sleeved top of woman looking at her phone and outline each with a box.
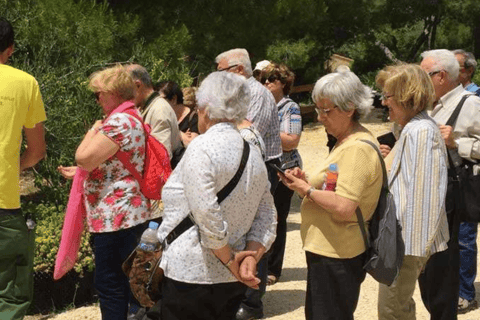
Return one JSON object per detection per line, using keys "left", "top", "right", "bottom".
{"left": 300, "top": 130, "right": 383, "bottom": 258}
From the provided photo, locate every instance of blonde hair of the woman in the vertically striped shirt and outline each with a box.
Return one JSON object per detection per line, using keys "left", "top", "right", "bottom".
{"left": 375, "top": 64, "right": 435, "bottom": 113}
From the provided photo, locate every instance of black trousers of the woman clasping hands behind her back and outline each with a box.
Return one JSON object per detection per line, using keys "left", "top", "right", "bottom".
{"left": 161, "top": 278, "right": 247, "bottom": 320}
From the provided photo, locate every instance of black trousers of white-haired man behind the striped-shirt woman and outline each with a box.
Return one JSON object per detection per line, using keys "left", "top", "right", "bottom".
{"left": 418, "top": 179, "right": 460, "bottom": 320}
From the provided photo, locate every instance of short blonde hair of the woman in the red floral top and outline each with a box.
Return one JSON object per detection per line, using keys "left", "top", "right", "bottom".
{"left": 88, "top": 64, "right": 135, "bottom": 101}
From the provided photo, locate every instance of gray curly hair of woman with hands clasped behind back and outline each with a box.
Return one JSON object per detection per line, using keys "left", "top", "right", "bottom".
{"left": 197, "top": 71, "right": 250, "bottom": 122}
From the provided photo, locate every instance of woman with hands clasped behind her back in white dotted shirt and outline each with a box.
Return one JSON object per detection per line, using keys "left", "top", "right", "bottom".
{"left": 158, "top": 72, "right": 276, "bottom": 320}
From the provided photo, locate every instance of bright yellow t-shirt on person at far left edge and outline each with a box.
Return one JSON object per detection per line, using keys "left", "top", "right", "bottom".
{"left": 0, "top": 64, "right": 46, "bottom": 209}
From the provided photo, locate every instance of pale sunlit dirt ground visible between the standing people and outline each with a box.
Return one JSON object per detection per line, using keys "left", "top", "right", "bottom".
{"left": 25, "top": 111, "right": 480, "bottom": 320}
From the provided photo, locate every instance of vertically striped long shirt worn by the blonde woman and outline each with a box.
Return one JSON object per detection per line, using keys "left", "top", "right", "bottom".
{"left": 389, "top": 111, "right": 449, "bottom": 257}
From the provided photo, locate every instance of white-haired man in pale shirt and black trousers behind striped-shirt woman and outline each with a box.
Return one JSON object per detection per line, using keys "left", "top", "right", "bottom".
{"left": 418, "top": 49, "right": 480, "bottom": 319}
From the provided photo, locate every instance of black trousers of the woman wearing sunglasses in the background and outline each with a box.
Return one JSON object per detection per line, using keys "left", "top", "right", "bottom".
{"left": 268, "top": 183, "right": 293, "bottom": 279}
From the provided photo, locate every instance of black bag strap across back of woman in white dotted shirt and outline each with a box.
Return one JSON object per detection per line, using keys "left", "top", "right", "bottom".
{"left": 165, "top": 139, "right": 250, "bottom": 244}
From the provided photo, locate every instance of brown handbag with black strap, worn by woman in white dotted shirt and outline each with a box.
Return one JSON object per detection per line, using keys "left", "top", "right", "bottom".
{"left": 122, "top": 140, "right": 250, "bottom": 308}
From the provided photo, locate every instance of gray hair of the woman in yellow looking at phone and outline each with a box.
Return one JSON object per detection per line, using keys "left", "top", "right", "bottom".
{"left": 312, "top": 71, "right": 373, "bottom": 121}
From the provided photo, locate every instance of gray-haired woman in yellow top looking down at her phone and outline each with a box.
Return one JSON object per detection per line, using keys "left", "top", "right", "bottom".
{"left": 281, "top": 71, "right": 382, "bottom": 320}
